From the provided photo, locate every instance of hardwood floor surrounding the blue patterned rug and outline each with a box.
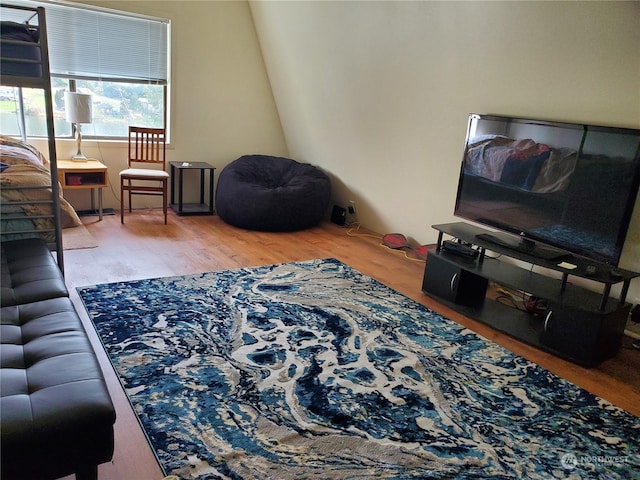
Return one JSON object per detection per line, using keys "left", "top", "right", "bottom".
{"left": 65, "top": 211, "right": 640, "bottom": 480}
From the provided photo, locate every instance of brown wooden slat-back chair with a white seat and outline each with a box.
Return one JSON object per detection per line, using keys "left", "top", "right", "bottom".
{"left": 120, "top": 126, "right": 169, "bottom": 225}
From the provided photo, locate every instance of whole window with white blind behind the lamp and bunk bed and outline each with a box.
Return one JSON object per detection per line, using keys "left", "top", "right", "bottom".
{"left": 0, "top": 0, "right": 170, "bottom": 138}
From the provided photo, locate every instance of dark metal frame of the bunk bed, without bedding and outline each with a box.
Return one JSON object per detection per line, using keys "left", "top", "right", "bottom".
{"left": 0, "top": 3, "right": 64, "bottom": 274}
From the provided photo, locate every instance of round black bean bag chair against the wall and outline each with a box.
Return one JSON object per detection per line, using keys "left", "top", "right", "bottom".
{"left": 216, "top": 155, "right": 331, "bottom": 232}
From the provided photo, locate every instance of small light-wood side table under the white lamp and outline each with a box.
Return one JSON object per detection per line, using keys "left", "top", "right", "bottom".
{"left": 58, "top": 160, "right": 109, "bottom": 220}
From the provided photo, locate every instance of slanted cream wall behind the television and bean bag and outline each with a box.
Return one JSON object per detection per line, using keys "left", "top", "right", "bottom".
{"left": 250, "top": 1, "right": 640, "bottom": 301}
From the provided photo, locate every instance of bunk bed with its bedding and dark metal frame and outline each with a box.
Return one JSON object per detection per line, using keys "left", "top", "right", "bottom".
{"left": 0, "top": 4, "right": 68, "bottom": 272}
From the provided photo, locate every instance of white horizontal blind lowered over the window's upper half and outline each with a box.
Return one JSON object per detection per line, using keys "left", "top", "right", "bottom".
{"left": 8, "top": 1, "right": 170, "bottom": 85}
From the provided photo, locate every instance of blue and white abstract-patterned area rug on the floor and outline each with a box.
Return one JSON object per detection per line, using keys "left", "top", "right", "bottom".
{"left": 78, "top": 259, "right": 640, "bottom": 480}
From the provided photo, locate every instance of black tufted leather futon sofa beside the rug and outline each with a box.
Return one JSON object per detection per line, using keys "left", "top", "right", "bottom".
{"left": 0, "top": 239, "right": 115, "bottom": 480}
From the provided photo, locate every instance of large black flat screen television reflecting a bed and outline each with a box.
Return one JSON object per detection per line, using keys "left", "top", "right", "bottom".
{"left": 454, "top": 114, "right": 640, "bottom": 266}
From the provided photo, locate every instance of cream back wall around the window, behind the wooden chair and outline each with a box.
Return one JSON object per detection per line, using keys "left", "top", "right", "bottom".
{"left": 45, "top": 0, "right": 288, "bottom": 209}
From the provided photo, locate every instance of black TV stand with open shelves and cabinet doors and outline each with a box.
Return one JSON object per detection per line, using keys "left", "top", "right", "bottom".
{"left": 422, "top": 222, "right": 640, "bottom": 367}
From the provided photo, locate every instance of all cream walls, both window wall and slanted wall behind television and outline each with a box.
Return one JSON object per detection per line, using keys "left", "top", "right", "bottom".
{"left": 26, "top": 1, "right": 640, "bottom": 301}
